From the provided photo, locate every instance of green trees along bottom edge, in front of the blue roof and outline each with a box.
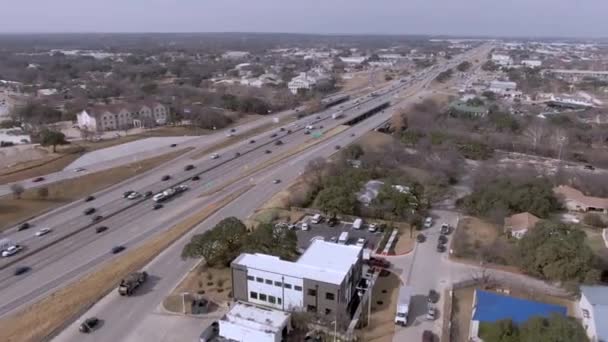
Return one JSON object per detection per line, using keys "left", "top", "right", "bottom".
{"left": 479, "top": 314, "right": 589, "bottom": 342}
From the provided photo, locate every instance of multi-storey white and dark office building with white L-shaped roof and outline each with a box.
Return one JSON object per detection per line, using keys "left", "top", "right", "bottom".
{"left": 231, "top": 240, "right": 363, "bottom": 328}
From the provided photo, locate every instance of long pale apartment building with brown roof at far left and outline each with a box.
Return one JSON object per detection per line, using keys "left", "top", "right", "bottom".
{"left": 76, "top": 101, "right": 169, "bottom": 132}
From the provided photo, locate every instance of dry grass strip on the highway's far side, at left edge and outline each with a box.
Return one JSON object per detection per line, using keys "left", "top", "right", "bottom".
{"left": 0, "top": 148, "right": 191, "bottom": 231}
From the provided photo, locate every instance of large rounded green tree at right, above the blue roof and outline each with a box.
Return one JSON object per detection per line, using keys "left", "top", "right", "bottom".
{"left": 518, "top": 221, "right": 595, "bottom": 282}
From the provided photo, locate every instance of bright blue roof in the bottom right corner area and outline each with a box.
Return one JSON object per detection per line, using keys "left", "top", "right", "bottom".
{"left": 473, "top": 290, "right": 568, "bottom": 324}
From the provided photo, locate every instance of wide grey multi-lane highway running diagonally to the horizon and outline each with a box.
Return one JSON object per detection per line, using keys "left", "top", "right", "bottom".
{"left": 0, "top": 44, "right": 490, "bottom": 341}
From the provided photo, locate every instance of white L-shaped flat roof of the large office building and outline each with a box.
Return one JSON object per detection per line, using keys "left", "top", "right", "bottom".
{"left": 233, "top": 240, "right": 362, "bottom": 285}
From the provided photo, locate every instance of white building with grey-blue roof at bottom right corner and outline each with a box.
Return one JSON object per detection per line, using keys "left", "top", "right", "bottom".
{"left": 578, "top": 285, "right": 608, "bottom": 342}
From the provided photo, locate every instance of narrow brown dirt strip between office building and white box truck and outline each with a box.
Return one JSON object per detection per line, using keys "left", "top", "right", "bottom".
{"left": 358, "top": 273, "right": 401, "bottom": 342}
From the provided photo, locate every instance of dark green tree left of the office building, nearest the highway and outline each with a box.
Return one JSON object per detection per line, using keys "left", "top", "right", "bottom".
{"left": 182, "top": 217, "right": 247, "bottom": 266}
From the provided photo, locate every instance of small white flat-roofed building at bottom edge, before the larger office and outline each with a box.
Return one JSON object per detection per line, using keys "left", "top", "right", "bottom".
{"left": 218, "top": 302, "right": 291, "bottom": 342}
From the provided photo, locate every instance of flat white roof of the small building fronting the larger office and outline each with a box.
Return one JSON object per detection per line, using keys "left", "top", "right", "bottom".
{"left": 221, "top": 302, "right": 290, "bottom": 333}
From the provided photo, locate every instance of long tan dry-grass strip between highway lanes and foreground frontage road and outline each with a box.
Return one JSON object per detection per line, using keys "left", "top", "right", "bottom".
{"left": 0, "top": 187, "right": 251, "bottom": 342}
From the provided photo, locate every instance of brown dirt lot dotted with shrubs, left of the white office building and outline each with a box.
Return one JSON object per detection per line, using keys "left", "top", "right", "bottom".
{"left": 163, "top": 263, "right": 232, "bottom": 313}
